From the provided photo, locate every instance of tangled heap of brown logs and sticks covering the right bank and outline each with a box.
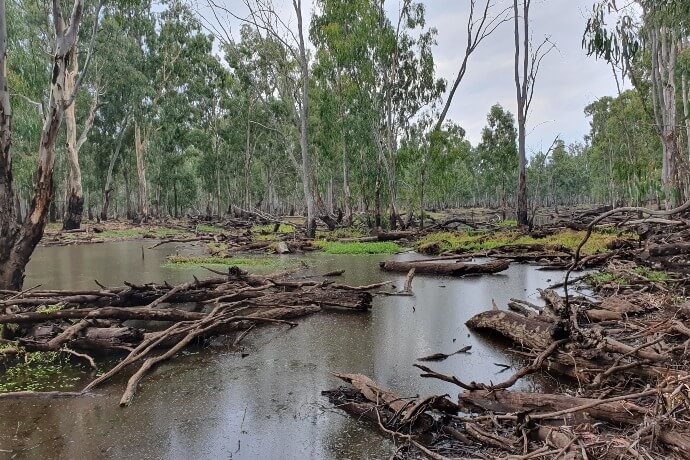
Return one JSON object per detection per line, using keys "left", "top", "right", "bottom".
{"left": 324, "top": 207, "right": 690, "bottom": 459}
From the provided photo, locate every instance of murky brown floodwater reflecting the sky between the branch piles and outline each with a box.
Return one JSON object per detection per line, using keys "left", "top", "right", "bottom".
{"left": 0, "top": 242, "right": 560, "bottom": 459}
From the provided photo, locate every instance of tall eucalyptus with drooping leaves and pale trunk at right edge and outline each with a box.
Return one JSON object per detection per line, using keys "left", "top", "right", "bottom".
{"left": 583, "top": 0, "right": 690, "bottom": 207}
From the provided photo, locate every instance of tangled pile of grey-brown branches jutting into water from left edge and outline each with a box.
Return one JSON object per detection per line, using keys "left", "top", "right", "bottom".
{"left": 0, "top": 267, "right": 374, "bottom": 405}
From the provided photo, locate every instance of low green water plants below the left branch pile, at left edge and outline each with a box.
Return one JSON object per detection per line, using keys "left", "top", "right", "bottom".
{"left": 0, "top": 351, "right": 81, "bottom": 393}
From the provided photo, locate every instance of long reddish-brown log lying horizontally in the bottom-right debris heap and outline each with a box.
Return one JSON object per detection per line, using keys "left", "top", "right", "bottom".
{"left": 459, "top": 390, "right": 647, "bottom": 425}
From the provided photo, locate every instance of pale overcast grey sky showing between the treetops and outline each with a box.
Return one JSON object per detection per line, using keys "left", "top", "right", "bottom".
{"left": 200, "top": 0, "right": 616, "bottom": 155}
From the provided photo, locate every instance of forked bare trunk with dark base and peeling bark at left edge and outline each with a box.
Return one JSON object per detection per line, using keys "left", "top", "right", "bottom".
{"left": 0, "top": 0, "right": 100, "bottom": 290}
